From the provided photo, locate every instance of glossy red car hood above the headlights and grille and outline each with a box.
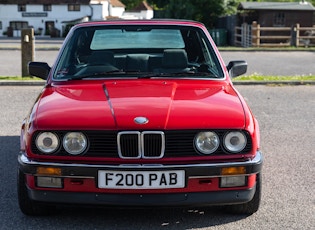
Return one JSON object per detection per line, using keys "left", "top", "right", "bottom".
{"left": 33, "top": 79, "right": 245, "bottom": 130}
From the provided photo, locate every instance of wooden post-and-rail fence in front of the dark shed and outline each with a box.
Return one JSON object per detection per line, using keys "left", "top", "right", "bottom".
{"left": 235, "top": 22, "right": 315, "bottom": 47}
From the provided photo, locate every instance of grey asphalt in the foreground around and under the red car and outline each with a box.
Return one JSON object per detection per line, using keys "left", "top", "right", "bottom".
{"left": 0, "top": 86, "right": 315, "bottom": 230}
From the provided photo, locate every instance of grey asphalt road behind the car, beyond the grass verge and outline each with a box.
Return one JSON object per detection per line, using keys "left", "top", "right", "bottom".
{"left": 0, "top": 37, "right": 315, "bottom": 84}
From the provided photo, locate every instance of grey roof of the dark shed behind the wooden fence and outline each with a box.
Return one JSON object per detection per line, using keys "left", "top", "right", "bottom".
{"left": 237, "top": 1, "right": 315, "bottom": 11}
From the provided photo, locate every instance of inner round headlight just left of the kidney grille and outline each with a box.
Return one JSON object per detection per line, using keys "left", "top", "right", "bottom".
{"left": 63, "top": 132, "right": 87, "bottom": 155}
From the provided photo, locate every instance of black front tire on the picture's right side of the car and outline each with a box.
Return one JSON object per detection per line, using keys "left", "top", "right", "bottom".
{"left": 226, "top": 173, "right": 262, "bottom": 215}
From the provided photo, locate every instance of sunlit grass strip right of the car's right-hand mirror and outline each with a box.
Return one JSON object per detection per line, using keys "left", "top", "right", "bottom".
{"left": 233, "top": 74, "right": 315, "bottom": 82}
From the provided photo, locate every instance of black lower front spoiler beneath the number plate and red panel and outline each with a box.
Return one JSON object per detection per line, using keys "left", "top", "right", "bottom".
{"left": 28, "top": 187, "right": 256, "bottom": 207}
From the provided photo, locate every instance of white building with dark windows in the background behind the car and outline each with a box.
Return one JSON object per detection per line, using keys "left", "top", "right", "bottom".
{"left": 0, "top": 0, "right": 153, "bottom": 37}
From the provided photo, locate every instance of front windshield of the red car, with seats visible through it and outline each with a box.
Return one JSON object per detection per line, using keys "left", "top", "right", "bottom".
{"left": 53, "top": 25, "right": 223, "bottom": 80}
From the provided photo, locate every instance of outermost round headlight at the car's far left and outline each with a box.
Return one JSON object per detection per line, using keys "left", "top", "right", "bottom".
{"left": 35, "top": 132, "right": 59, "bottom": 154}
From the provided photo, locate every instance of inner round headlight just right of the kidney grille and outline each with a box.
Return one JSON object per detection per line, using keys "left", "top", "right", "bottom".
{"left": 195, "top": 132, "right": 220, "bottom": 154}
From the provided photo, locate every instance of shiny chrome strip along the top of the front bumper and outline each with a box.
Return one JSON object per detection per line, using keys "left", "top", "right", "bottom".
{"left": 18, "top": 151, "right": 263, "bottom": 170}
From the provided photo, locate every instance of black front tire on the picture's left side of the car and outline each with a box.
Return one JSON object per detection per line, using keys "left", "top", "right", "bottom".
{"left": 17, "top": 170, "right": 55, "bottom": 216}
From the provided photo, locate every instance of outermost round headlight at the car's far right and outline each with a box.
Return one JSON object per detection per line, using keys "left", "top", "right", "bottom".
{"left": 224, "top": 131, "right": 247, "bottom": 153}
